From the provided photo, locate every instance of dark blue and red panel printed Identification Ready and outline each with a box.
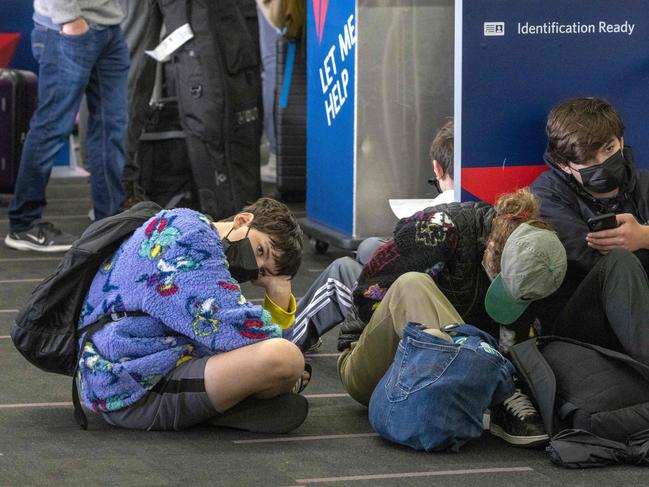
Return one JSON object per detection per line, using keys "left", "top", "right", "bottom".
{"left": 456, "top": 0, "right": 649, "bottom": 200}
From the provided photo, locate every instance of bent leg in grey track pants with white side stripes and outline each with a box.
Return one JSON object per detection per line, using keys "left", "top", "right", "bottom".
{"left": 284, "top": 257, "right": 363, "bottom": 350}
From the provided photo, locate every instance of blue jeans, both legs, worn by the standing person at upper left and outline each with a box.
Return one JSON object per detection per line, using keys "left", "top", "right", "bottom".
{"left": 9, "top": 24, "right": 129, "bottom": 232}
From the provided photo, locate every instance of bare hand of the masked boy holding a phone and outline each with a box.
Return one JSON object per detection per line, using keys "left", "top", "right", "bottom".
{"left": 586, "top": 213, "right": 649, "bottom": 254}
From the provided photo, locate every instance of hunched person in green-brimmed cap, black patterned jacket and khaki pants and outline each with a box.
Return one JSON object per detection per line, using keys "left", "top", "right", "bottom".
{"left": 338, "top": 189, "right": 566, "bottom": 445}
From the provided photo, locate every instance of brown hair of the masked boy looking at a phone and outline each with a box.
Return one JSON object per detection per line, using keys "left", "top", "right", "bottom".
{"left": 545, "top": 98, "right": 624, "bottom": 164}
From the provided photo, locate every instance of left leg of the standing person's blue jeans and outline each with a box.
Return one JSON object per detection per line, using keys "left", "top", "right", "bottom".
{"left": 9, "top": 25, "right": 97, "bottom": 232}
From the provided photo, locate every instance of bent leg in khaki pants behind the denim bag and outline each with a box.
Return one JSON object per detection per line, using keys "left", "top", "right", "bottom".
{"left": 338, "top": 272, "right": 463, "bottom": 405}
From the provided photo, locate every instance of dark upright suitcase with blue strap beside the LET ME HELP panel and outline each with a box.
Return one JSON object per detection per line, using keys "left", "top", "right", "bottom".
{"left": 275, "top": 37, "right": 306, "bottom": 201}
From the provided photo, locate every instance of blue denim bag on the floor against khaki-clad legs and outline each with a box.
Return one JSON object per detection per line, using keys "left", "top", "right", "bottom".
{"left": 369, "top": 323, "right": 514, "bottom": 451}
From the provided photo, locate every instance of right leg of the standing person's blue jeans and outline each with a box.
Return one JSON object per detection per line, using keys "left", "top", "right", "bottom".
{"left": 86, "top": 26, "right": 129, "bottom": 220}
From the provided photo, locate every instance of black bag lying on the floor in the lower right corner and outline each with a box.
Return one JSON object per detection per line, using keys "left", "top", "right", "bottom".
{"left": 510, "top": 336, "right": 649, "bottom": 468}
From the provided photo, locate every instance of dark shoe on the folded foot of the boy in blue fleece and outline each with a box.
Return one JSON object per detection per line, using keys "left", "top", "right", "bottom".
{"left": 210, "top": 394, "right": 309, "bottom": 434}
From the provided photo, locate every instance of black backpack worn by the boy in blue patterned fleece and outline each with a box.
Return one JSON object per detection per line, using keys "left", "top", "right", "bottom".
{"left": 11, "top": 201, "right": 161, "bottom": 429}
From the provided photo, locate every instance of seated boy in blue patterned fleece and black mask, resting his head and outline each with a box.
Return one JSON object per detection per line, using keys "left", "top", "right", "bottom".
{"left": 79, "top": 198, "right": 307, "bottom": 432}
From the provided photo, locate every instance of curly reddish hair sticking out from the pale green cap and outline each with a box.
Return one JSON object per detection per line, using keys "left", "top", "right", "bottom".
{"left": 487, "top": 188, "right": 551, "bottom": 275}
